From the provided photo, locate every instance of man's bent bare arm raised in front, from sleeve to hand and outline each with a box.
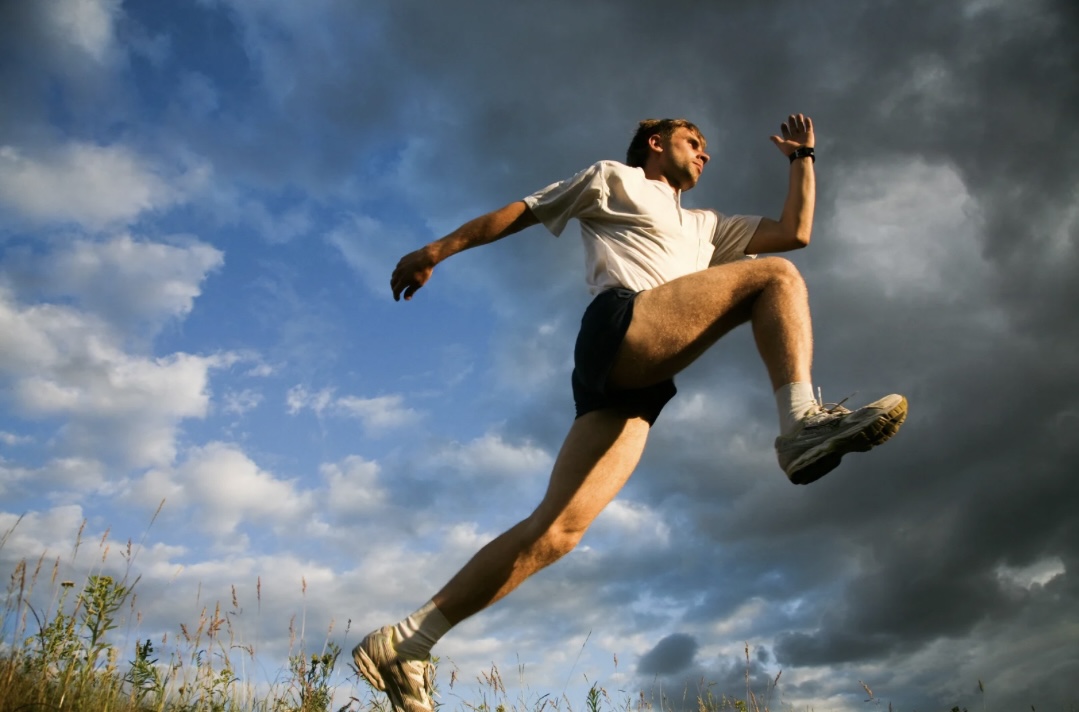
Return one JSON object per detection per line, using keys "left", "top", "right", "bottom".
{"left": 746, "top": 113, "right": 817, "bottom": 255}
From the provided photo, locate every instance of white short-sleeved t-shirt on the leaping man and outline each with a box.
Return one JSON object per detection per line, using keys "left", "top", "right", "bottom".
{"left": 524, "top": 161, "right": 761, "bottom": 295}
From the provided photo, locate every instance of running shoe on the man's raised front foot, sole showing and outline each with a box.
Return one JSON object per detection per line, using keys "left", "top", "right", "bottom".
{"left": 776, "top": 394, "right": 906, "bottom": 484}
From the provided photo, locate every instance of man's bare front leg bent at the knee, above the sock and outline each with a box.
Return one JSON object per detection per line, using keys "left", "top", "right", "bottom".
{"left": 611, "top": 257, "right": 812, "bottom": 389}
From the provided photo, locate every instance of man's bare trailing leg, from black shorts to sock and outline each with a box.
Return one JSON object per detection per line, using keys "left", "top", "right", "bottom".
{"left": 434, "top": 410, "right": 648, "bottom": 625}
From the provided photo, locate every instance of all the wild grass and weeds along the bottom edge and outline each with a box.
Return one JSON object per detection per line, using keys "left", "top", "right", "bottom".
{"left": 6, "top": 503, "right": 1053, "bottom": 712}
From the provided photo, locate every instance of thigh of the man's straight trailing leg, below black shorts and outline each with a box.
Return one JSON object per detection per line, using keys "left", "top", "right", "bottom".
{"left": 532, "top": 409, "right": 650, "bottom": 534}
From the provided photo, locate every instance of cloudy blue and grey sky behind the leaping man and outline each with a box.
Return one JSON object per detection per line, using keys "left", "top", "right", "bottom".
{"left": 0, "top": 0, "right": 1079, "bottom": 711}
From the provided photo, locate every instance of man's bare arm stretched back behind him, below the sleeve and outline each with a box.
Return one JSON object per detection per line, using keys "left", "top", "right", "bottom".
{"left": 390, "top": 201, "right": 538, "bottom": 301}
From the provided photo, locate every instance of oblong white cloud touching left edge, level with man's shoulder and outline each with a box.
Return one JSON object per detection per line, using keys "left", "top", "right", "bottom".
{"left": 0, "top": 141, "right": 200, "bottom": 228}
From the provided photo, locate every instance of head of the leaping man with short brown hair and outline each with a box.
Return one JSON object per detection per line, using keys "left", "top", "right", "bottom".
{"left": 626, "top": 119, "right": 708, "bottom": 190}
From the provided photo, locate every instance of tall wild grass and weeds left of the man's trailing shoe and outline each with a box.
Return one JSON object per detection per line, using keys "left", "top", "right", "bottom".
{"left": 0, "top": 503, "right": 360, "bottom": 712}
